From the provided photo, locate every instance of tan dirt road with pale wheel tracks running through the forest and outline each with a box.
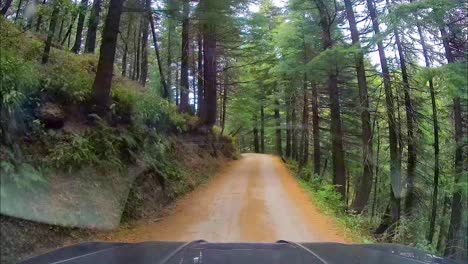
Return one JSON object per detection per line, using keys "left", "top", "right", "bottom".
{"left": 105, "top": 154, "right": 347, "bottom": 243}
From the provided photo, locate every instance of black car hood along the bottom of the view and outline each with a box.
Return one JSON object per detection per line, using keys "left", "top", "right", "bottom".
{"left": 23, "top": 241, "right": 456, "bottom": 264}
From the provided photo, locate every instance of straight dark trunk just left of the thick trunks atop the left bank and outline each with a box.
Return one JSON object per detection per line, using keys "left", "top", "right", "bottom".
{"left": 179, "top": 0, "right": 190, "bottom": 113}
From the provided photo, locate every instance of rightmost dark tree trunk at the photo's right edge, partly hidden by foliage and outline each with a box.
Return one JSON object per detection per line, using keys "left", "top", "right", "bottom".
{"left": 440, "top": 27, "right": 468, "bottom": 258}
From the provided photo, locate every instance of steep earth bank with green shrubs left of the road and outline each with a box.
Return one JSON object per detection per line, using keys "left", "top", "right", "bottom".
{"left": 0, "top": 18, "right": 234, "bottom": 263}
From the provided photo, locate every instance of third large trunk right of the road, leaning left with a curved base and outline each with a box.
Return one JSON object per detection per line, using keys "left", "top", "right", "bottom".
{"left": 366, "top": 0, "right": 401, "bottom": 233}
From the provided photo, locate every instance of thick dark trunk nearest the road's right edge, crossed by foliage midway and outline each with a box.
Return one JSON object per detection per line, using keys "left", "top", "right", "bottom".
{"left": 315, "top": 0, "right": 346, "bottom": 197}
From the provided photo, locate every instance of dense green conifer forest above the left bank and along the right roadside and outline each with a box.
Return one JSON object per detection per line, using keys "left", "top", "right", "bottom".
{"left": 0, "top": 0, "right": 468, "bottom": 258}
